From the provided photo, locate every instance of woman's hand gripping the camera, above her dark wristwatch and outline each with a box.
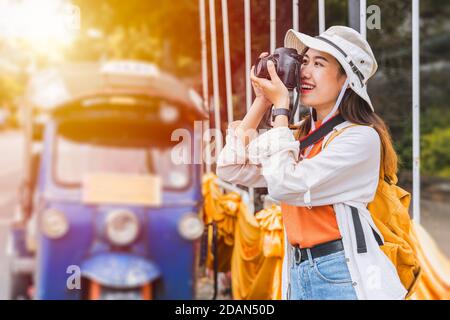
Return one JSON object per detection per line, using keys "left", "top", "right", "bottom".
{"left": 250, "top": 57, "right": 289, "bottom": 108}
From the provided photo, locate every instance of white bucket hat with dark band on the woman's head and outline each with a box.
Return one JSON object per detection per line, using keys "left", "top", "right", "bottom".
{"left": 284, "top": 26, "right": 378, "bottom": 111}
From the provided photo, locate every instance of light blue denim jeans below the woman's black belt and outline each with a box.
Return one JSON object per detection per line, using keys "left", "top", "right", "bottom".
{"left": 288, "top": 250, "right": 357, "bottom": 300}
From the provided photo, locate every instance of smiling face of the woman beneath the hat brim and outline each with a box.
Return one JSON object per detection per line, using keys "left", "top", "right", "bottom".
{"left": 300, "top": 49, "right": 345, "bottom": 111}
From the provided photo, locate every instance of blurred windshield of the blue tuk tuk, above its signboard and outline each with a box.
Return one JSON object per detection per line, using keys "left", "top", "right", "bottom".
{"left": 54, "top": 121, "right": 190, "bottom": 189}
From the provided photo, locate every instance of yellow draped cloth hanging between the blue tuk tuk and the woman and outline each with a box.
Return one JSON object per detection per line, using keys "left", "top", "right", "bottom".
{"left": 202, "top": 173, "right": 283, "bottom": 300}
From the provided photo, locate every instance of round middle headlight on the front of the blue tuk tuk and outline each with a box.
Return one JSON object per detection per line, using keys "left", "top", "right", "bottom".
{"left": 106, "top": 210, "right": 139, "bottom": 246}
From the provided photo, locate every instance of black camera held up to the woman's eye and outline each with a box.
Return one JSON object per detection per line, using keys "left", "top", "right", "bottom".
{"left": 255, "top": 48, "right": 302, "bottom": 90}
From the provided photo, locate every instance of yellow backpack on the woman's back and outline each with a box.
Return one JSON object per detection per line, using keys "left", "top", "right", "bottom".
{"left": 324, "top": 124, "right": 421, "bottom": 297}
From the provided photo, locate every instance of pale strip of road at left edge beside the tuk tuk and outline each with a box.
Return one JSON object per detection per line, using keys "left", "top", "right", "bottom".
{"left": 0, "top": 131, "right": 24, "bottom": 299}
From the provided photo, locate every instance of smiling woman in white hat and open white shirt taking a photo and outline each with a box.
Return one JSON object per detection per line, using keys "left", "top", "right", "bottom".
{"left": 217, "top": 26, "right": 406, "bottom": 299}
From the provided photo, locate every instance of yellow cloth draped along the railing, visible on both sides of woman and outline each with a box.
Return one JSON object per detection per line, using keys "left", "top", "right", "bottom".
{"left": 203, "top": 174, "right": 450, "bottom": 300}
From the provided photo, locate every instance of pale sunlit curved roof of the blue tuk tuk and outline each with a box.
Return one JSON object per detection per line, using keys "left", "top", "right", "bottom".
{"left": 27, "top": 61, "right": 207, "bottom": 119}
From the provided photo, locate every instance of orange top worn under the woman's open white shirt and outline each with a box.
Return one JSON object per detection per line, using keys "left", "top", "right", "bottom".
{"left": 281, "top": 121, "right": 342, "bottom": 248}
